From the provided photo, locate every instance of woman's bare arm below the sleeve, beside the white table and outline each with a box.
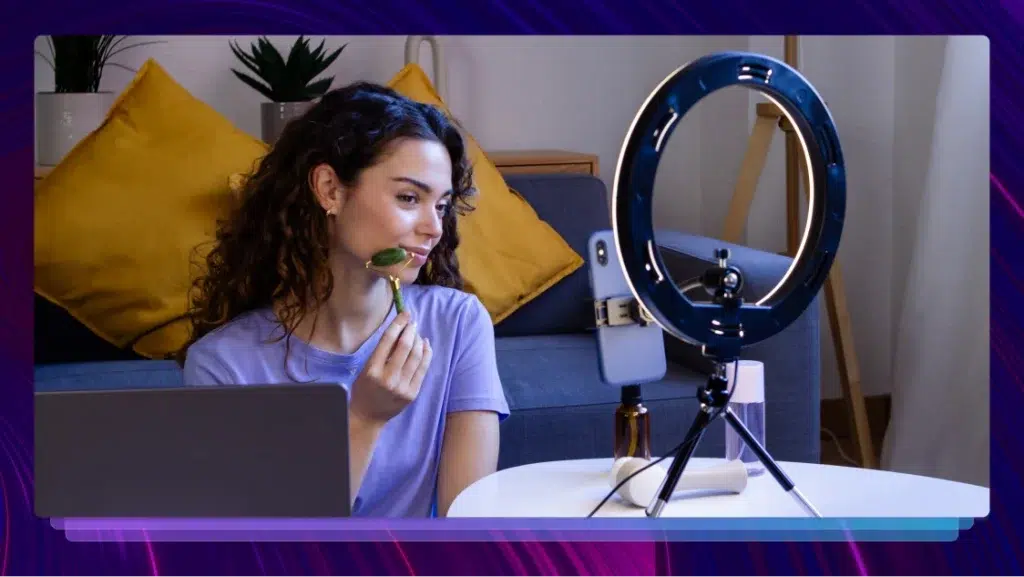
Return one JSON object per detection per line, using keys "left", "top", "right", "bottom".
{"left": 437, "top": 411, "right": 499, "bottom": 517}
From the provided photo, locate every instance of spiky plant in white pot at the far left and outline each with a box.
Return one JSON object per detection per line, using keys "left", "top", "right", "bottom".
{"left": 36, "top": 34, "right": 158, "bottom": 166}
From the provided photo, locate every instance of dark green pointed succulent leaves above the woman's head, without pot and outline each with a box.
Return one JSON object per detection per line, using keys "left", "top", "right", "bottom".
{"left": 230, "top": 36, "right": 348, "bottom": 102}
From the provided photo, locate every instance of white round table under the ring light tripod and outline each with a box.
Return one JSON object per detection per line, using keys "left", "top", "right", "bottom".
{"left": 449, "top": 457, "right": 989, "bottom": 519}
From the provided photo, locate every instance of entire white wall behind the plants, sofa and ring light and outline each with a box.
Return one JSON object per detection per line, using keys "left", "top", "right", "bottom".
{"left": 36, "top": 36, "right": 958, "bottom": 397}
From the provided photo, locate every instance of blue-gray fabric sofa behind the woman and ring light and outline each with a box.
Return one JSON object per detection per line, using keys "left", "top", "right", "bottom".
{"left": 35, "top": 174, "right": 820, "bottom": 468}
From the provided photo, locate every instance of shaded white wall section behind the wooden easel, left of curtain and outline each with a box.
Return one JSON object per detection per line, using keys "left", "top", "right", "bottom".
{"left": 746, "top": 36, "right": 901, "bottom": 398}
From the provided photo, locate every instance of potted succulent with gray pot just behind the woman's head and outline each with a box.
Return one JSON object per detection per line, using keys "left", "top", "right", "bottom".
{"left": 230, "top": 36, "right": 347, "bottom": 143}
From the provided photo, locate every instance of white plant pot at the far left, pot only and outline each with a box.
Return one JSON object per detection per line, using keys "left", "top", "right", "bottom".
{"left": 36, "top": 92, "right": 116, "bottom": 166}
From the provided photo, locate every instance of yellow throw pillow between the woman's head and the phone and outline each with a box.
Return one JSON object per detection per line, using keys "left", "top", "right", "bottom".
{"left": 388, "top": 64, "right": 583, "bottom": 324}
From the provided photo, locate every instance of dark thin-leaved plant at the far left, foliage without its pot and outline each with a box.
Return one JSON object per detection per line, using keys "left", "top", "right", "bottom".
{"left": 36, "top": 34, "right": 161, "bottom": 93}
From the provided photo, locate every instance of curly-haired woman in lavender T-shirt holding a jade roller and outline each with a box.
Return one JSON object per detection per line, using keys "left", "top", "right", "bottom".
{"left": 178, "top": 83, "right": 508, "bottom": 517}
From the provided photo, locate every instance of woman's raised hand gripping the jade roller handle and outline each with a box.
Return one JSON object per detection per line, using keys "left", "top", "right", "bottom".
{"left": 349, "top": 312, "right": 433, "bottom": 426}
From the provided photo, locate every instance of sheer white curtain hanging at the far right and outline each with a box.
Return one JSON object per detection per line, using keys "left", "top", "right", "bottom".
{"left": 882, "top": 37, "right": 989, "bottom": 486}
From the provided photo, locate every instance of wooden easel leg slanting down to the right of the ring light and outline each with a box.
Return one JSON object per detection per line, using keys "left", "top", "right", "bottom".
{"left": 800, "top": 163, "right": 879, "bottom": 468}
